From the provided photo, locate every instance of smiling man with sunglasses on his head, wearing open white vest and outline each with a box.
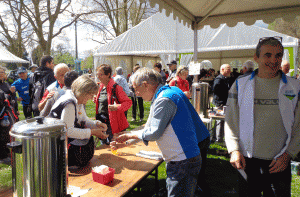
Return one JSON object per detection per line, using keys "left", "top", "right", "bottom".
{"left": 225, "top": 37, "right": 300, "bottom": 197}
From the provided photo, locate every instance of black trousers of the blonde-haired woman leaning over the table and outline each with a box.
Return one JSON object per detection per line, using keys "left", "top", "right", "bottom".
{"left": 68, "top": 137, "right": 95, "bottom": 167}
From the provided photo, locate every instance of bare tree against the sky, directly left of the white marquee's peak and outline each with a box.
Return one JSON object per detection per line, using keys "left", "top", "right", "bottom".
{"left": 80, "top": 0, "right": 158, "bottom": 44}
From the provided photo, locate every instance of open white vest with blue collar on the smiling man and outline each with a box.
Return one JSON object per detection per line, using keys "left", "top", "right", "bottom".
{"left": 236, "top": 71, "right": 300, "bottom": 159}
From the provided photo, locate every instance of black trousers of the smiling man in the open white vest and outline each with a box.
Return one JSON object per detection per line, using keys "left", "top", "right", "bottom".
{"left": 245, "top": 157, "right": 292, "bottom": 197}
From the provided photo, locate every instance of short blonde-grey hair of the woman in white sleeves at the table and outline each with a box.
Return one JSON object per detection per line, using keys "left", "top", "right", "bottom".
{"left": 71, "top": 75, "right": 98, "bottom": 98}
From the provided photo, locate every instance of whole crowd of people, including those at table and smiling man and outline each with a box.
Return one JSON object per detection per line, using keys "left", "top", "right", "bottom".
{"left": 0, "top": 37, "right": 300, "bottom": 197}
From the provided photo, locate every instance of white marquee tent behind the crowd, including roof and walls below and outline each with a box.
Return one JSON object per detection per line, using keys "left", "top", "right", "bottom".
{"left": 95, "top": 11, "right": 298, "bottom": 69}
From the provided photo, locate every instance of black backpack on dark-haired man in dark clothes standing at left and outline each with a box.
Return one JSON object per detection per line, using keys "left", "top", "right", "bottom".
{"left": 30, "top": 71, "right": 49, "bottom": 111}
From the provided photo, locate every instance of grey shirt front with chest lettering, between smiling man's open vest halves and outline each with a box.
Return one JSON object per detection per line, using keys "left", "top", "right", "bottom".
{"left": 253, "top": 75, "right": 288, "bottom": 160}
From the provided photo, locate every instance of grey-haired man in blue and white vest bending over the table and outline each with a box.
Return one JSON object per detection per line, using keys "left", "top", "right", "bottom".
{"left": 116, "top": 68, "right": 209, "bottom": 196}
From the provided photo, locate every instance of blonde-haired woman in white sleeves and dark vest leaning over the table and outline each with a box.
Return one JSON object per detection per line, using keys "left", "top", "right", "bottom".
{"left": 50, "top": 75, "right": 108, "bottom": 167}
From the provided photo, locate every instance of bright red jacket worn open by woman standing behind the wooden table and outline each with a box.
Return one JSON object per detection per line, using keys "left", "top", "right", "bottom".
{"left": 96, "top": 79, "right": 132, "bottom": 134}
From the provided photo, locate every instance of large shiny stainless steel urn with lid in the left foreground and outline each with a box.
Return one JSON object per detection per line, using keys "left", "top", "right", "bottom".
{"left": 8, "top": 117, "right": 67, "bottom": 197}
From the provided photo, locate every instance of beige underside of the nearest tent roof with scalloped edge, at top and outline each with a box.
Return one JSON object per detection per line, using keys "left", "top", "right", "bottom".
{"left": 150, "top": 0, "right": 300, "bottom": 29}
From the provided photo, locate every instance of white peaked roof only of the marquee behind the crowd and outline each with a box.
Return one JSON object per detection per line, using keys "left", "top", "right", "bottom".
{"left": 95, "top": 11, "right": 298, "bottom": 56}
